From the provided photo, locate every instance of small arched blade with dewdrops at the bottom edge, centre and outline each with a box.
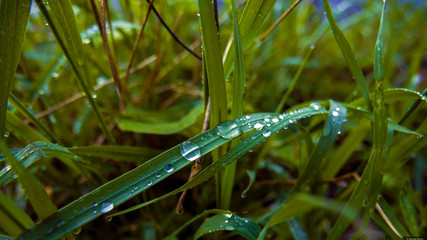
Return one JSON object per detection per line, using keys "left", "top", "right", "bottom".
{"left": 194, "top": 214, "right": 261, "bottom": 240}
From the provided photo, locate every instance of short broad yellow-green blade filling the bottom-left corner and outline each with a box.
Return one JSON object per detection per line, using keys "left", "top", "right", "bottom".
{"left": 0, "top": 191, "right": 34, "bottom": 237}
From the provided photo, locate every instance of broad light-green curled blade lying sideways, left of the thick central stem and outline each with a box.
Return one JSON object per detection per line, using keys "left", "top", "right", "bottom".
{"left": 118, "top": 102, "right": 204, "bottom": 134}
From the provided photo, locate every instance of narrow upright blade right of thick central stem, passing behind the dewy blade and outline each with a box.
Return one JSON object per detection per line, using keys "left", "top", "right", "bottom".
{"left": 220, "top": 0, "right": 246, "bottom": 209}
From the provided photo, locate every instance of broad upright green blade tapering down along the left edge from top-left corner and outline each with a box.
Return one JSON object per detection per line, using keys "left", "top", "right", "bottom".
{"left": 0, "top": 0, "right": 31, "bottom": 141}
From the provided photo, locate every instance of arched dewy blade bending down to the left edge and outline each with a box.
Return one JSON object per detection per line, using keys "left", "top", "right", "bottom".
{"left": 0, "top": 142, "right": 88, "bottom": 186}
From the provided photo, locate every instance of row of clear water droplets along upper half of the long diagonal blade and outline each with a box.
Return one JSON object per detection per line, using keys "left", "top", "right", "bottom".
{"left": 180, "top": 103, "right": 321, "bottom": 161}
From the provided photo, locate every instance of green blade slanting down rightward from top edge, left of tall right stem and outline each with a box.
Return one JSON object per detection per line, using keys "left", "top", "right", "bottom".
{"left": 323, "top": 0, "right": 372, "bottom": 110}
